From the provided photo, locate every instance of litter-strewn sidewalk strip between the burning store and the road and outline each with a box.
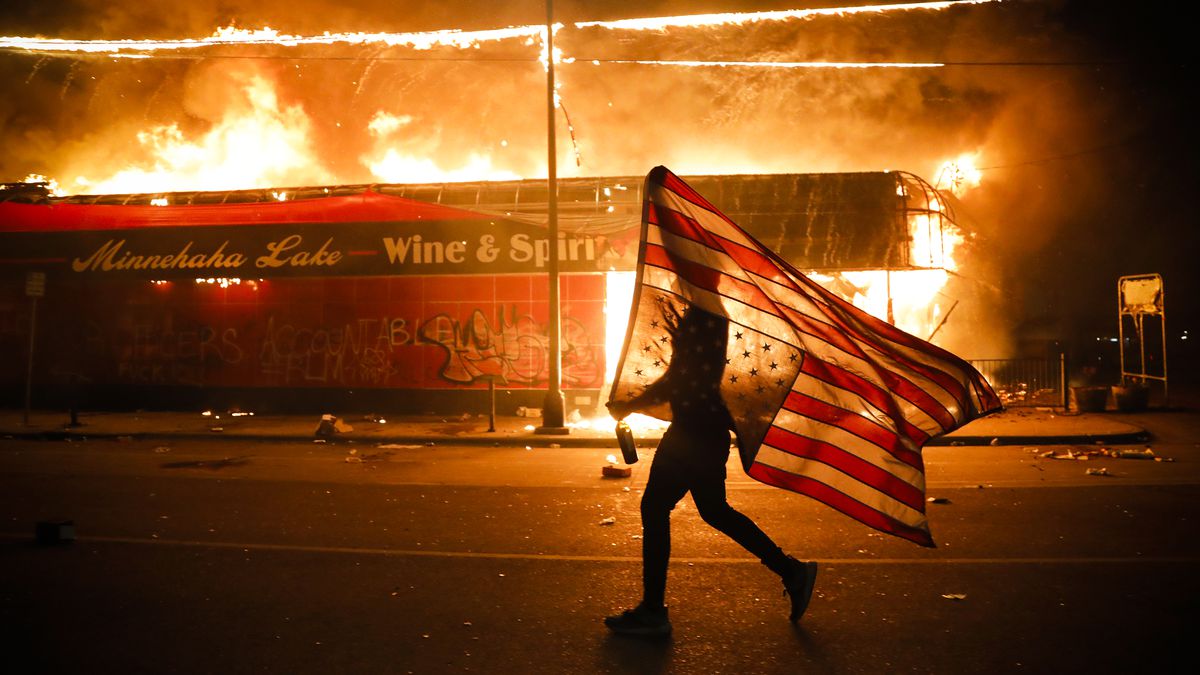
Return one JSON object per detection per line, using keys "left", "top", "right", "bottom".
{"left": 0, "top": 408, "right": 1150, "bottom": 448}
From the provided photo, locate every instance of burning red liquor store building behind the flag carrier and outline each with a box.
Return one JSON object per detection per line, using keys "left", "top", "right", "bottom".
{"left": 0, "top": 172, "right": 962, "bottom": 414}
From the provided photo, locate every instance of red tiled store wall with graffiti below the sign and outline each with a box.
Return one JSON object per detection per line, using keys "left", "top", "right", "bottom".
{"left": 0, "top": 274, "right": 605, "bottom": 403}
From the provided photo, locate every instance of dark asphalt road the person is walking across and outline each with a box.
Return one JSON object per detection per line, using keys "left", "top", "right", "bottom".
{"left": 0, "top": 414, "right": 1200, "bottom": 674}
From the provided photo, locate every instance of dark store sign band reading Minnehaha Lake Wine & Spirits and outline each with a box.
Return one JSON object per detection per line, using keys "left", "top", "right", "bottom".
{"left": 5, "top": 220, "right": 636, "bottom": 279}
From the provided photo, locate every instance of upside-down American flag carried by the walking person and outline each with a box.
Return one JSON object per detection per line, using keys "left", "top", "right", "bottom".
{"left": 610, "top": 167, "right": 1001, "bottom": 546}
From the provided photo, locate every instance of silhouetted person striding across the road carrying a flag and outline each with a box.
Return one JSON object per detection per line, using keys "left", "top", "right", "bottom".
{"left": 605, "top": 306, "right": 817, "bottom": 637}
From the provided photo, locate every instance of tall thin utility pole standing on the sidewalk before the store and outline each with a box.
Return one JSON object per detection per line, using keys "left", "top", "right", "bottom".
{"left": 536, "top": 0, "right": 570, "bottom": 434}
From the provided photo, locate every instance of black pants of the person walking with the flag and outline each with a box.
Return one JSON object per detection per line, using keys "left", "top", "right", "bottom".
{"left": 642, "top": 425, "right": 787, "bottom": 607}
